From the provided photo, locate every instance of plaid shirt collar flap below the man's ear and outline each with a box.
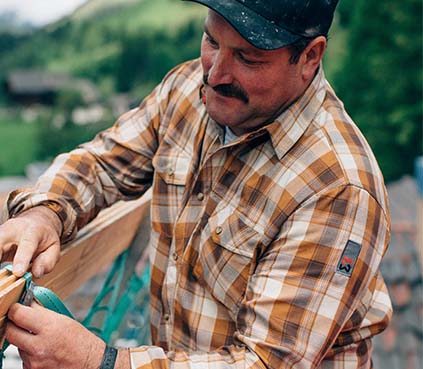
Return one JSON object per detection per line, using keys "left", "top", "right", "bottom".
{"left": 264, "top": 66, "right": 326, "bottom": 160}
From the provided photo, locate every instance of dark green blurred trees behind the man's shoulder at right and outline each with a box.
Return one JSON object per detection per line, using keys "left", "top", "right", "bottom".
{"left": 334, "top": 0, "right": 423, "bottom": 181}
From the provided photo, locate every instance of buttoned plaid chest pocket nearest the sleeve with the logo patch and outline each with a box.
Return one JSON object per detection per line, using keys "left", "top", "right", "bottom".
{"left": 193, "top": 210, "right": 263, "bottom": 320}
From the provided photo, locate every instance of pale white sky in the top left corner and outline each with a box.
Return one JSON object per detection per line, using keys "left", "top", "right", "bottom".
{"left": 0, "top": 0, "right": 87, "bottom": 25}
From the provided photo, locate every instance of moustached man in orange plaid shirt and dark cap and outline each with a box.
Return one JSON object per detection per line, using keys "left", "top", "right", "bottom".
{"left": 0, "top": 0, "right": 391, "bottom": 369}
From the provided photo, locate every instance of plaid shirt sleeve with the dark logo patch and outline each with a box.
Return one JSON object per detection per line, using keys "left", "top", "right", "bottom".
{"left": 131, "top": 185, "right": 391, "bottom": 369}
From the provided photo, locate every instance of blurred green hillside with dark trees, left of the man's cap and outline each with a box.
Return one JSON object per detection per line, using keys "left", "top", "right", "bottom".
{"left": 0, "top": 0, "right": 205, "bottom": 98}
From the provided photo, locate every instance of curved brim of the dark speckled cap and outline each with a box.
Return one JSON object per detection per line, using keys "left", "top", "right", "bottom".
{"left": 185, "top": 0, "right": 301, "bottom": 50}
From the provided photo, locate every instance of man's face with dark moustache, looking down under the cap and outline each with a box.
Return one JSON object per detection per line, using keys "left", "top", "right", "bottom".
{"left": 201, "top": 10, "right": 306, "bottom": 135}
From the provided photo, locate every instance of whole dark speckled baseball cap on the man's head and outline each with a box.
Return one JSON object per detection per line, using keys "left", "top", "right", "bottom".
{"left": 186, "top": 0, "right": 338, "bottom": 50}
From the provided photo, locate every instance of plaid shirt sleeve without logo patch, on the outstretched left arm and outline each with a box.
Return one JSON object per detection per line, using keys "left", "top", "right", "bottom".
{"left": 3, "top": 86, "right": 163, "bottom": 243}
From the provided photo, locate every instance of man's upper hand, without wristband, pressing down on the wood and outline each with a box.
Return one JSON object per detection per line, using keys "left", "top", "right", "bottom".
{"left": 0, "top": 206, "right": 62, "bottom": 278}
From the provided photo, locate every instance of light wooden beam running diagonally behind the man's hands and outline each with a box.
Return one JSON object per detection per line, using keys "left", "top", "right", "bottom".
{"left": 0, "top": 191, "right": 151, "bottom": 343}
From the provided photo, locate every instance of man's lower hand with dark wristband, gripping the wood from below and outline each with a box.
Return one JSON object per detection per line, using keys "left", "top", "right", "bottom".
{"left": 6, "top": 303, "right": 130, "bottom": 369}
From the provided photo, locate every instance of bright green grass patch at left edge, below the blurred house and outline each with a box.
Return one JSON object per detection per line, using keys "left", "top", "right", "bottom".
{"left": 0, "top": 120, "right": 37, "bottom": 176}
